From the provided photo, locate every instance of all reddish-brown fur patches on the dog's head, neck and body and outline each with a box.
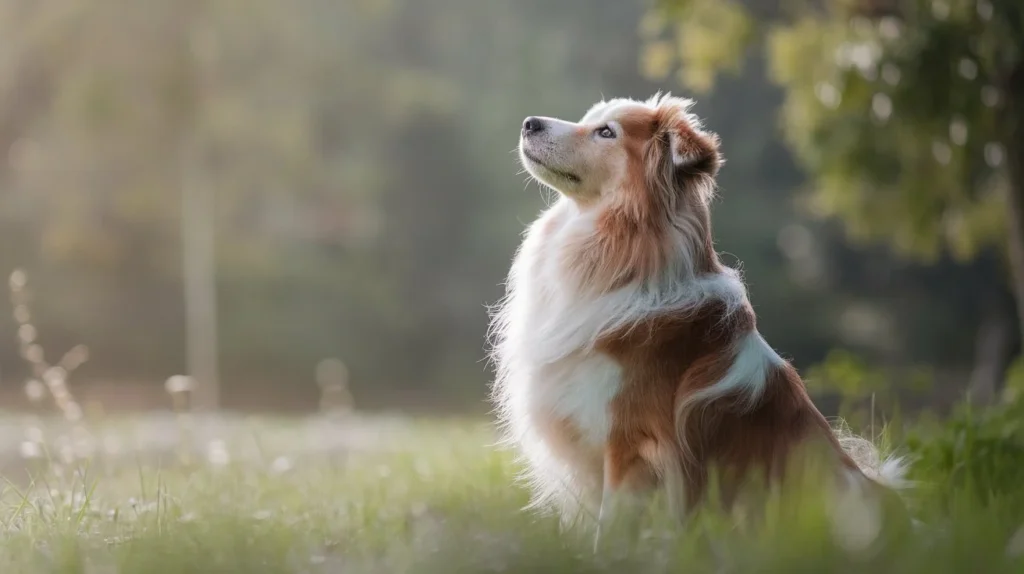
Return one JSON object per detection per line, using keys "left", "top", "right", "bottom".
{"left": 570, "top": 97, "right": 856, "bottom": 507}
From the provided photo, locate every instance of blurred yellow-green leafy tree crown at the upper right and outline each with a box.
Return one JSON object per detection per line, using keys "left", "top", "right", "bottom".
{"left": 642, "top": 0, "right": 1024, "bottom": 398}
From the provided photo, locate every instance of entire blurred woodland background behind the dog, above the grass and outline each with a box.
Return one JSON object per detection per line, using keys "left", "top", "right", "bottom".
{"left": 0, "top": 0, "right": 1024, "bottom": 421}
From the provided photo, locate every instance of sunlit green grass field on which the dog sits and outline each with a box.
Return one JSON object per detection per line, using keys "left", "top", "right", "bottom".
{"left": 0, "top": 409, "right": 1024, "bottom": 574}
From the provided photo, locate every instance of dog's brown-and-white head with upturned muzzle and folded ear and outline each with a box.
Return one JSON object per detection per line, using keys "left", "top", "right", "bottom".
{"left": 519, "top": 91, "right": 722, "bottom": 208}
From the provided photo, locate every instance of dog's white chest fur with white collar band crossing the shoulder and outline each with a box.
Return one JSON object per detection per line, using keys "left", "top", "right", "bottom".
{"left": 493, "top": 198, "right": 746, "bottom": 442}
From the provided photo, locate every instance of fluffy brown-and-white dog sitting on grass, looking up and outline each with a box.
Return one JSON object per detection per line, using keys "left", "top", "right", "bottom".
{"left": 490, "top": 94, "right": 904, "bottom": 529}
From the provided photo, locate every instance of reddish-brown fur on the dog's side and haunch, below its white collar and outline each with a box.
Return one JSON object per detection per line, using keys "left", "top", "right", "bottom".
{"left": 599, "top": 294, "right": 856, "bottom": 507}
